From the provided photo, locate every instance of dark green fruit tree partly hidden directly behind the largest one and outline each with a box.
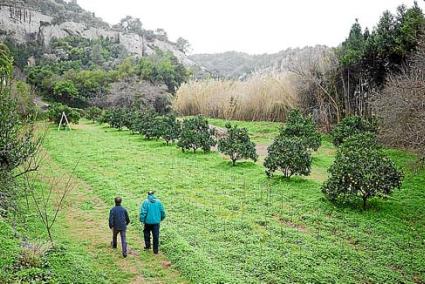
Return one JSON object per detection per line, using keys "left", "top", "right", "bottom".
{"left": 331, "top": 116, "right": 378, "bottom": 146}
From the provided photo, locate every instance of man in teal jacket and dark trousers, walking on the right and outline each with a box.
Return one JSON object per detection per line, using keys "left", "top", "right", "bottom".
{"left": 140, "top": 191, "right": 165, "bottom": 254}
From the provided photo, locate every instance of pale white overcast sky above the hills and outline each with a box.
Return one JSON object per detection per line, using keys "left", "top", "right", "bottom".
{"left": 74, "top": 0, "right": 425, "bottom": 54}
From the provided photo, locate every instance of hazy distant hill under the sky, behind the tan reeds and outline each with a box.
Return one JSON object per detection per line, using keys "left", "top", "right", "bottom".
{"left": 189, "top": 45, "right": 330, "bottom": 79}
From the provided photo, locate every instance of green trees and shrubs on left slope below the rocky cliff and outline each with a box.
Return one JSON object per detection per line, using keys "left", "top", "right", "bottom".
{"left": 18, "top": 36, "right": 189, "bottom": 107}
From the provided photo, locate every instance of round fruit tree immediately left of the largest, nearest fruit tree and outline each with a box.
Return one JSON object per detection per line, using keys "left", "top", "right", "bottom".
{"left": 264, "top": 136, "right": 311, "bottom": 178}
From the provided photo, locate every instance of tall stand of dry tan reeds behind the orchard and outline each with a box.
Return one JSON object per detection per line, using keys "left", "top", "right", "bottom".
{"left": 173, "top": 73, "right": 298, "bottom": 121}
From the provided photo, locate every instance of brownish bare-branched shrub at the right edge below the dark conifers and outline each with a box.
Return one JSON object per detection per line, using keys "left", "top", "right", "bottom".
{"left": 373, "top": 37, "right": 425, "bottom": 164}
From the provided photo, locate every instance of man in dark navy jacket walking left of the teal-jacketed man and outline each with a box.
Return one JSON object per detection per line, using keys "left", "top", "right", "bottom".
{"left": 109, "top": 197, "right": 130, "bottom": 257}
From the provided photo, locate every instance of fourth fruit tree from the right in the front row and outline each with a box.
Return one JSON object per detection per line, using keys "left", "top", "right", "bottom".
{"left": 177, "top": 115, "right": 216, "bottom": 152}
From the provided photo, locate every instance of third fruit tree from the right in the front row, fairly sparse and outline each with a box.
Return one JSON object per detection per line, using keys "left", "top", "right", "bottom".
{"left": 218, "top": 123, "right": 258, "bottom": 166}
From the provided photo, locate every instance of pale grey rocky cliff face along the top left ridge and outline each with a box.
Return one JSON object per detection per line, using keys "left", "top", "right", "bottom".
{"left": 0, "top": 0, "right": 195, "bottom": 66}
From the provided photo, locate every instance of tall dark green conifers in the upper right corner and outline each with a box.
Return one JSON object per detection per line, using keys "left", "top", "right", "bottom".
{"left": 339, "top": 2, "right": 425, "bottom": 76}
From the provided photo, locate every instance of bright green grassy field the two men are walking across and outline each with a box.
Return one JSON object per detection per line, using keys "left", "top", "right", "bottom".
{"left": 11, "top": 117, "right": 425, "bottom": 283}
